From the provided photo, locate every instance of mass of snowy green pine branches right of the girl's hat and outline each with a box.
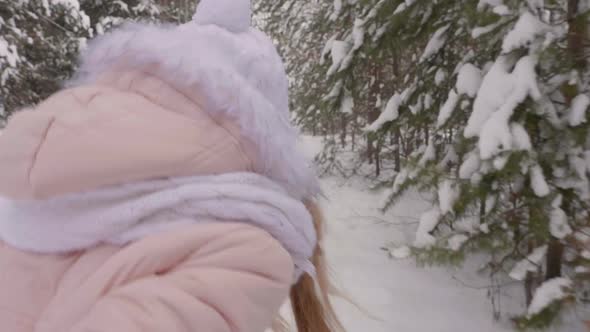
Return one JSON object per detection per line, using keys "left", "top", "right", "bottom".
{"left": 283, "top": 0, "right": 590, "bottom": 329}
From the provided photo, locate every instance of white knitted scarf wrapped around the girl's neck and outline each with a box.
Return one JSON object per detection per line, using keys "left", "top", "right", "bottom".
{"left": 0, "top": 173, "right": 317, "bottom": 280}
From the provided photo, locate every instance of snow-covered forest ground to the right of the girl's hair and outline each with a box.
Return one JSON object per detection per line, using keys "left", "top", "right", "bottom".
{"left": 303, "top": 137, "right": 583, "bottom": 332}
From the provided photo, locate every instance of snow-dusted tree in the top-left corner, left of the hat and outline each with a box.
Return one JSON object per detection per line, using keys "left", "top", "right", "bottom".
{"left": 0, "top": 0, "right": 92, "bottom": 119}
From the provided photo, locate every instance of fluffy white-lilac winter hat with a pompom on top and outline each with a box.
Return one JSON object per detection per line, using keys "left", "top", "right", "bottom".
{"left": 74, "top": 0, "right": 319, "bottom": 198}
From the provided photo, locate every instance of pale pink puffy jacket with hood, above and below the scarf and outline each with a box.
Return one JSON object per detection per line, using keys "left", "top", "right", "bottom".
{"left": 0, "top": 71, "right": 293, "bottom": 332}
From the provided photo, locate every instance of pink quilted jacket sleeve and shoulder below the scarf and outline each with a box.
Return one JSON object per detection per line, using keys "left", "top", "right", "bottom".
{"left": 68, "top": 224, "right": 293, "bottom": 332}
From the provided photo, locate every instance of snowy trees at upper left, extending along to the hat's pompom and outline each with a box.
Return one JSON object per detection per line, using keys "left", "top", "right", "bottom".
{"left": 0, "top": 0, "right": 198, "bottom": 120}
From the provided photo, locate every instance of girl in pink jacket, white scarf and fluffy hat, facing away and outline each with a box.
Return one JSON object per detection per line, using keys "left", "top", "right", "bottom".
{"left": 0, "top": 0, "right": 339, "bottom": 332}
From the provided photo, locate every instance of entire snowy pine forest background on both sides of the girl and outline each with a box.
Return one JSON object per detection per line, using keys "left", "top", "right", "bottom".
{"left": 0, "top": 0, "right": 590, "bottom": 332}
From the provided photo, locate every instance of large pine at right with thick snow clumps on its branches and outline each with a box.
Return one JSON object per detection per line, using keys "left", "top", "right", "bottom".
{"left": 380, "top": 0, "right": 590, "bottom": 328}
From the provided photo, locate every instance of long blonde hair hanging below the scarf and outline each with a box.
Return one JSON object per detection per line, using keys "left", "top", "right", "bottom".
{"left": 282, "top": 201, "right": 344, "bottom": 332}
